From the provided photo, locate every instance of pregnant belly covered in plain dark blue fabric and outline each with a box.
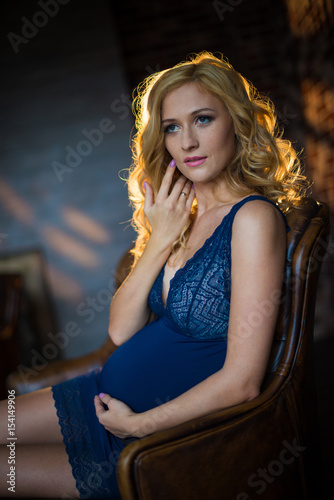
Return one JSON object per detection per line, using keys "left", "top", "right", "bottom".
{"left": 100, "top": 319, "right": 226, "bottom": 412}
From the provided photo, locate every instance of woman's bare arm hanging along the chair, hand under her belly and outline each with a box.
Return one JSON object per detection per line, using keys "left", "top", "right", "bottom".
{"left": 95, "top": 201, "right": 286, "bottom": 437}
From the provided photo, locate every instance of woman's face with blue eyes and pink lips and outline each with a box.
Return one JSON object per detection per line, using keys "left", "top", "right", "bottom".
{"left": 161, "top": 82, "right": 235, "bottom": 183}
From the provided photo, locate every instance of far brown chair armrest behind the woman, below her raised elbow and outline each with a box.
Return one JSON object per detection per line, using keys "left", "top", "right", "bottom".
{"left": 6, "top": 337, "right": 116, "bottom": 395}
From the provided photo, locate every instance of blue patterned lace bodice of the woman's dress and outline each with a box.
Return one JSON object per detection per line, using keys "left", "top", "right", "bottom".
{"left": 149, "top": 195, "right": 285, "bottom": 340}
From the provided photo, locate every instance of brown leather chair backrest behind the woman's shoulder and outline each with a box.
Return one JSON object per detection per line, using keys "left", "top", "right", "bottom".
{"left": 263, "top": 198, "right": 329, "bottom": 388}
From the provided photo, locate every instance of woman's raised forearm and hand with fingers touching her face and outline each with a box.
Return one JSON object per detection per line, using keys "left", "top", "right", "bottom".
{"left": 108, "top": 164, "right": 195, "bottom": 345}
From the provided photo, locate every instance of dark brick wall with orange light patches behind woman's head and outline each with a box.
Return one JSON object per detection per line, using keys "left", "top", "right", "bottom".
{"left": 111, "top": 0, "right": 334, "bottom": 336}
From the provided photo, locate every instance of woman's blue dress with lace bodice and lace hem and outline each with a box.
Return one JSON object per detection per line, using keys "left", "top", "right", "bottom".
{"left": 52, "top": 195, "right": 285, "bottom": 498}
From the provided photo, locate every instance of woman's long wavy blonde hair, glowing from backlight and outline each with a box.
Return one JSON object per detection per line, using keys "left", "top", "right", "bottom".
{"left": 127, "top": 51, "right": 308, "bottom": 262}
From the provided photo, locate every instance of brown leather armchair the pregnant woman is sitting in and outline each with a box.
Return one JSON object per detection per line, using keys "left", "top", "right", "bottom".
{"left": 6, "top": 198, "right": 329, "bottom": 500}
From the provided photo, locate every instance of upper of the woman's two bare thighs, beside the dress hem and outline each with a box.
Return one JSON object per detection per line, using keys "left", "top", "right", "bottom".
{"left": 0, "top": 387, "right": 63, "bottom": 444}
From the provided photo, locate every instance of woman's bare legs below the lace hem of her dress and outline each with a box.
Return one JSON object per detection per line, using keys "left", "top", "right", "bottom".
{"left": 0, "top": 388, "right": 79, "bottom": 498}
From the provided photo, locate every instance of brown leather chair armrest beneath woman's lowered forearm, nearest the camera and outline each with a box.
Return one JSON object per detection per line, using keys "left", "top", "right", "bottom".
{"left": 117, "top": 378, "right": 305, "bottom": 500}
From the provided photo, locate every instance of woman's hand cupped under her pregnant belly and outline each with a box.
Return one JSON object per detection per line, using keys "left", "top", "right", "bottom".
{"left": 94, "top": 393, "right": 138, "bottom": 438}
